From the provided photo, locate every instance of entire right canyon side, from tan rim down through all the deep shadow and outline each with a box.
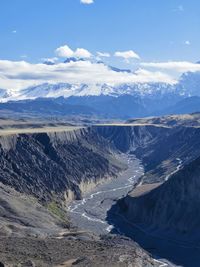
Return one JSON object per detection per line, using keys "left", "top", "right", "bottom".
{"left": 101, "top": 114, "right": 200, "bottom": 267}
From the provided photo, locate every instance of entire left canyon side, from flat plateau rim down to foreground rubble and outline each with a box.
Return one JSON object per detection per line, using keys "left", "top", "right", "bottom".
{"left": 0, "top": 121, "right": 157, "bottom": 267}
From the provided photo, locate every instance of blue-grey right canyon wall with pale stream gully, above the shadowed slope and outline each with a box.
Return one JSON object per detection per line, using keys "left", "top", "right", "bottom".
{"left": 135, "top": 125, "right": 200, "bottom": 183}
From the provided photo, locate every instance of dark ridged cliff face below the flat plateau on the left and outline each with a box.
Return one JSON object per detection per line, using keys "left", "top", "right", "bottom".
{"left": 0, "top": 128, "right": 124, "bottom": 202}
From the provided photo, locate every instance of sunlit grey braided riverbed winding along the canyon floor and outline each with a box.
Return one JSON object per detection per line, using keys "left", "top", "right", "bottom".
{"left": 68, "top": 155, "right": 144, "bottom": 234}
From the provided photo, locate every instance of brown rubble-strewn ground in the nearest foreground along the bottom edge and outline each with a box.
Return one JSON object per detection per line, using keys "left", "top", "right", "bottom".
{"left": 0, "top": 235, "right": 159, "bottom": 267}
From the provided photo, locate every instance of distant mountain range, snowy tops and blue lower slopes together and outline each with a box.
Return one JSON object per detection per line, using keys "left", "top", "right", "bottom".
{"left": 0, "top": 65, "right": 200, "bottom": 119}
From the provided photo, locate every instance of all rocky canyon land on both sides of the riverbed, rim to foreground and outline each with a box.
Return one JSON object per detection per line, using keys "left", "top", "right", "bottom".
{"left": 0, "top": 114, "right": 200, "bottom": 266}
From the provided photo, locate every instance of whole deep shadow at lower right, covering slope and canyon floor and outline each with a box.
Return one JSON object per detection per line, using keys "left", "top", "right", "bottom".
{"left": 107, "top": 158, "right": 200, "bottom": 267}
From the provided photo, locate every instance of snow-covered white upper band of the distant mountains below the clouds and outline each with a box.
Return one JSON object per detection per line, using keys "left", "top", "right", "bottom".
{"left": 0, "top": 69, "right": 200, "bottom": 102}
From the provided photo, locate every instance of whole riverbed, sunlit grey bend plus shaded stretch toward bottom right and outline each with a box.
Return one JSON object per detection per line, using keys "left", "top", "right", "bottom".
{"left": 68, "top": 155, "right": 181, "bottom": 267}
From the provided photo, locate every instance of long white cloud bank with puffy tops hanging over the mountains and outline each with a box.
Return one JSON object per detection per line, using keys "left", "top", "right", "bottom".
{"left": 0, "top": 41, "right": 200, "bottom": 90}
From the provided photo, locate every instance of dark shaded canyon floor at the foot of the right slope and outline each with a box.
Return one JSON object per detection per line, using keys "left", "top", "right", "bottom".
{"left": 107, "top": 202, "right": 200, "bottom": 267}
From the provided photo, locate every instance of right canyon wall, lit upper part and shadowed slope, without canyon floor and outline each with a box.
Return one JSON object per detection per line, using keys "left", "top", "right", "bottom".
{"left": 101, "top": 114, "right": 200, "bottom": 243}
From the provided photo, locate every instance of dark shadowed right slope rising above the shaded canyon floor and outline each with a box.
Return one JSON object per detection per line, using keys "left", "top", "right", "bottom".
{"left": 119, "top": 158, "right": 200, "bottom": 244}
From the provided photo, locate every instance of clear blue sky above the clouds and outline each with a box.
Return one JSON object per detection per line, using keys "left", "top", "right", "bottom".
{"left": 0, "top": 0, "right": 200, "bottom": 62}
